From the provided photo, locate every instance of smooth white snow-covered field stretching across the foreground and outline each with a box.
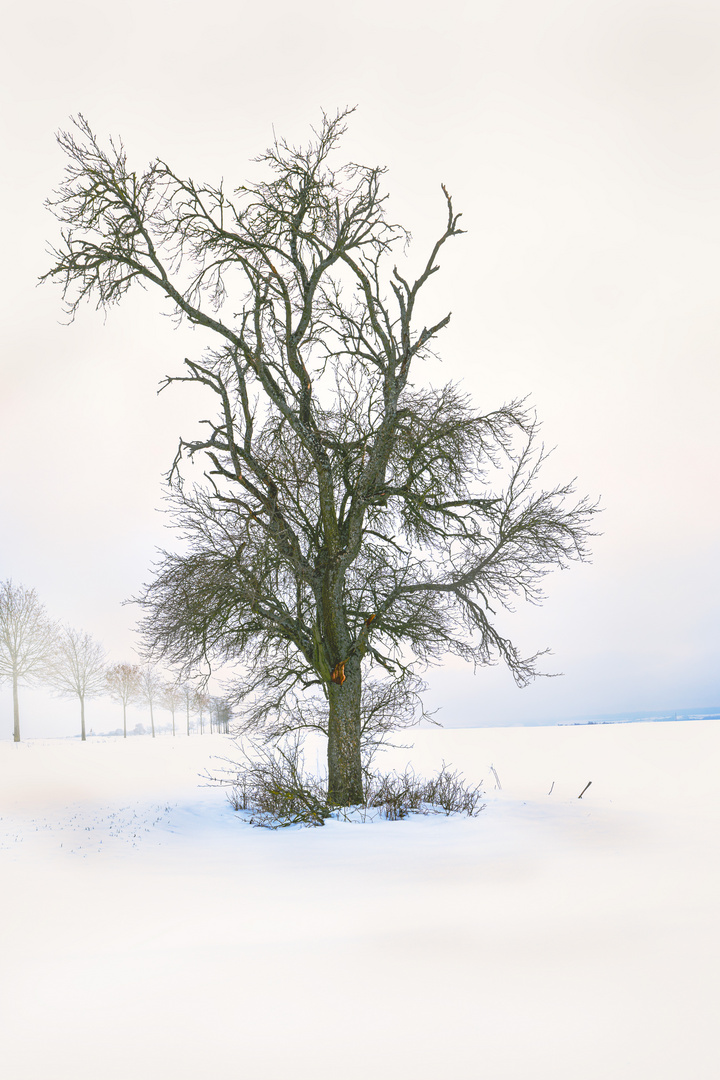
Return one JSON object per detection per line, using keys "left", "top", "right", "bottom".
{"left": 0, "top": 720, "right": 720, "bottom": 1080}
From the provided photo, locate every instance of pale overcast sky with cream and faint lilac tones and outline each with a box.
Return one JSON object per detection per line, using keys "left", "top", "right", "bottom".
{"left": 0, "top": 0, "right": 720, "bottom": 738}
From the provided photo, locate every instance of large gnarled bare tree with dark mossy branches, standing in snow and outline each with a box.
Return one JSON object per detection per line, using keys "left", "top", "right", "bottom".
{"left": 44, "top": 111, "right": 596, "bottom": 805}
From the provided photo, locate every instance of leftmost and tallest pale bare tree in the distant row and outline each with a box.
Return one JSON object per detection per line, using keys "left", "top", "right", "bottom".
{"left": 0, "top": 579, "right": 55, "bottom": 742}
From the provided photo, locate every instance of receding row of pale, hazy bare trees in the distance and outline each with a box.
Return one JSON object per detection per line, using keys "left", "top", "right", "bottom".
{"left": 0, "top": 579, "right": 230, "bottom": 742}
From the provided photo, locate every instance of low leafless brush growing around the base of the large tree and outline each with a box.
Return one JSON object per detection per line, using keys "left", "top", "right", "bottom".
{"left": 211, "top": 739, "right": 484, "bottom": 828}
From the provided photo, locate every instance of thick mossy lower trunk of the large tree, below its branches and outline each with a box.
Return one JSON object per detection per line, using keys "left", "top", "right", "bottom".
{"left": 327, "top": 657, "right": 363, "bottom": 807}
